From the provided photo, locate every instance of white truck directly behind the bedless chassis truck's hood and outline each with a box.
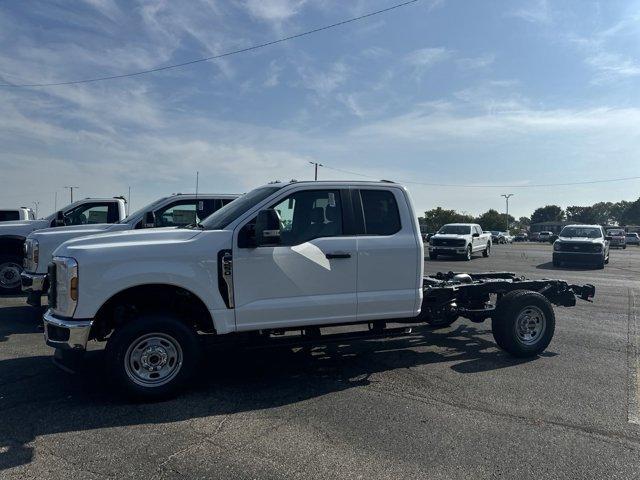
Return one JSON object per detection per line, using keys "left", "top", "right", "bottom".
{"left": 21, "top": 193, "right": 238, "bottom": 307}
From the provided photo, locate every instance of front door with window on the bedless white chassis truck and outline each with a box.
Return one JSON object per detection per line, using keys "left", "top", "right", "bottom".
{"left": 233, "top": 187, "right": 357, "bottom": 330}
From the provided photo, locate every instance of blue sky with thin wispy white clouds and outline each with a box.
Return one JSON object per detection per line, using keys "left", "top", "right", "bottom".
{"left": 0, "top": 0, "right": 640, "bottom": 216}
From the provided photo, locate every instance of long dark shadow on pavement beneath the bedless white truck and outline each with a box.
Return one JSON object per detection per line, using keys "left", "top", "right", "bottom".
{"left": 0, "top": 319, "right": 544, "bottom": 470}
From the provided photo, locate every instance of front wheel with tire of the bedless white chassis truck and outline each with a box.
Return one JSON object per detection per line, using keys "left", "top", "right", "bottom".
{"left": 106, "top": 314, "right": 202, "bottom": 399}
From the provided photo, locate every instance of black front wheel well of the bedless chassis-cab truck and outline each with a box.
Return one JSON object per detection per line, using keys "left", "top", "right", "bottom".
{"left": 91, "top": 284, "right": 215, "bottom": 340}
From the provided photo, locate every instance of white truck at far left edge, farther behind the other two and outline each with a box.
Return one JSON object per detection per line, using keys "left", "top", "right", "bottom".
{"left": 0, "top": 198, "right": 126, "bottom": 295}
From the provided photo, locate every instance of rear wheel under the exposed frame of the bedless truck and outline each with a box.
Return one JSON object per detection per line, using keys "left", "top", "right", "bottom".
{"left": 491, "top": 290, "right": 556, "bottom": 358}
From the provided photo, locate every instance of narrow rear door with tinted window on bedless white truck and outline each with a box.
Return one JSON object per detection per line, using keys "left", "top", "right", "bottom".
{"left": 352, "top": 188, "right": 424, "bottom": 320}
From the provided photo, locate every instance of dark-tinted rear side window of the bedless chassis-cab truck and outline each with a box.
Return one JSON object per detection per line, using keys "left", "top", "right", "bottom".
{"left": 360, "top": 190, "right": 400, "bottom": 235}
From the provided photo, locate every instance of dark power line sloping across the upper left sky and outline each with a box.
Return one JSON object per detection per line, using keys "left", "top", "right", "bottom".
{"left": 0, "top": 0, "right": 420, "bottom": 88}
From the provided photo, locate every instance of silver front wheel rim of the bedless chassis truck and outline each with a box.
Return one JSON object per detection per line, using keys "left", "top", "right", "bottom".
{"left": 124, "top": 333, "right": 183, "bottom": 387}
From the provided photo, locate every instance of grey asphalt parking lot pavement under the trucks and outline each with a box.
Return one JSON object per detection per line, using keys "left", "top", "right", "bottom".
{"left": 0, "top": 244, "right": 640, "bottom": 479}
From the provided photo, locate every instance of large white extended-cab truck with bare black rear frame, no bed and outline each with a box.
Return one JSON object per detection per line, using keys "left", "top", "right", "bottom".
{"left": 44, "top": 182, "right": 595, "bottom": 398}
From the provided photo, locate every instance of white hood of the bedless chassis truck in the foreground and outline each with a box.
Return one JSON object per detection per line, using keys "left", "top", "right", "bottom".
{"left": 53, "top": 227, "right": 202, "bottom": 257}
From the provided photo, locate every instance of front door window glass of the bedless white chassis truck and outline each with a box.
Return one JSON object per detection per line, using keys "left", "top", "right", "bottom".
{"left": 271, "top": 190, "right": 342, "bottom": 246}
